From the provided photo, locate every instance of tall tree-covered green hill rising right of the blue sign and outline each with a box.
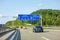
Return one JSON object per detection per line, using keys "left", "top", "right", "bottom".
{"left": 32, "top": 9, "right": 60, "bottom": 26}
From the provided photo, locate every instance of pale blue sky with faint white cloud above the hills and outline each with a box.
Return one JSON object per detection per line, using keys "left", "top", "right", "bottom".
{"left": 0, "top": 0, "right": 60, "bottom": 24}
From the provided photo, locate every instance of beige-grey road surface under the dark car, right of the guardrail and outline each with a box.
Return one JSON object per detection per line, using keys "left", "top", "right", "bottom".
{"left": 20, "top": 29, "right": 60, "bottom": 40}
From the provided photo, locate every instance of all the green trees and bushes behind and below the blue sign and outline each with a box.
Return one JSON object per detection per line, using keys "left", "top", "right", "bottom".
{"left": 6, "top": 9, "right": 60, "bottom": 27}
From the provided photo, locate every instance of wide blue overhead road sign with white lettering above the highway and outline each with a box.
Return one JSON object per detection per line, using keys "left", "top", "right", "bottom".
{"left": 18, "top": 14, "right": 40, "bottom": 20}
